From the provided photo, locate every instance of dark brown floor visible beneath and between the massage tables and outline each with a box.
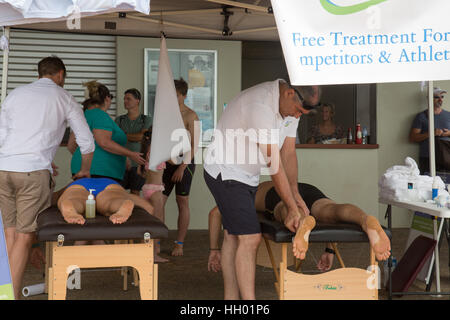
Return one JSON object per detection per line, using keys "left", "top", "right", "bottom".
{"left": 23, "top": 229, "right": 450, "bottom": 300}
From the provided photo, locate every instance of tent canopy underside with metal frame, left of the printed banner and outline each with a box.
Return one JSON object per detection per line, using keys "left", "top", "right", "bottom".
{"left": 0, "top": 0, "right": 279, "bottom": 41}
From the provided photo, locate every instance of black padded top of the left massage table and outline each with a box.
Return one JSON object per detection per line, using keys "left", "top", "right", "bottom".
{"left": 36, "top": 207, "right": 169, "bottom": 241}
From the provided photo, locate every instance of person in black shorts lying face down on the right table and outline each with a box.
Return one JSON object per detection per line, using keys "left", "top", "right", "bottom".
{"left": 208, "top": 181, "right": 391, "bottom": 271}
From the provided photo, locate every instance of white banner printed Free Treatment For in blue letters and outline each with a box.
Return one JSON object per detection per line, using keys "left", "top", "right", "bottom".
{"left": 272, "top": 0, "right": 450, "bottom": 85}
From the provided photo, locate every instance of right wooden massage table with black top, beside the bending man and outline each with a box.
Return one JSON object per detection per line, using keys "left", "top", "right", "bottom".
{"left": 258, "top": 212, "right": 391, "bottom": 300}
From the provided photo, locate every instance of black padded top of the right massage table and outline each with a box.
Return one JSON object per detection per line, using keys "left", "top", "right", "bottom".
{"left": 258, "top": 212, "right": 391, "bottom": 243}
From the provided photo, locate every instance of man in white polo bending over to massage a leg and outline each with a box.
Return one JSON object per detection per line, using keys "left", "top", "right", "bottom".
{"left": 204, "top": 79, "right": 319, "bottom": 299}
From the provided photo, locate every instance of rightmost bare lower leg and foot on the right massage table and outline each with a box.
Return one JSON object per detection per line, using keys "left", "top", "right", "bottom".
{"left": 311, "top": 199, "right": 391, "bottom": 261}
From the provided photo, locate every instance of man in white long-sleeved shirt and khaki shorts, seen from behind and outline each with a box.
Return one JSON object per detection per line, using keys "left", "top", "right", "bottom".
{"left": 0, "top": 56, "right": 95, "bottom": 299}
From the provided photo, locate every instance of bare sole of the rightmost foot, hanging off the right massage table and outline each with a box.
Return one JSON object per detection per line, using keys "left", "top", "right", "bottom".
{"left": 364, "top": 216, "right": 391, "bottom": 261}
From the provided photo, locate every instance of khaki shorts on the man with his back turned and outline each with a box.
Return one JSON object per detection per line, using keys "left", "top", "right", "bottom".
{"left": 0, "top": 170, "right": 55, "bottom": 233}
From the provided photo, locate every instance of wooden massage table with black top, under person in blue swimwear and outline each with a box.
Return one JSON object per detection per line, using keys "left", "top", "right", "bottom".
{"left": 37, "top": 207, "right": 169, "bottom": 300}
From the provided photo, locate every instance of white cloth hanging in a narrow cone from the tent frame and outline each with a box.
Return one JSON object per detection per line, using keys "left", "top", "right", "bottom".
{"left": 149, "top": 37, "right": 191, "bottom": 171}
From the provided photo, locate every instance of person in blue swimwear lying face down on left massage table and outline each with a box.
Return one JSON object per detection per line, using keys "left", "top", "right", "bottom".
{"left": 52, "top": 178, "right": 154, "bottom": 225}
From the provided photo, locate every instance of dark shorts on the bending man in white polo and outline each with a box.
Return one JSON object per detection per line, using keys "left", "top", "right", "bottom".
{"left": 203, "top": 170, "right": 261, "bottom": 235}
